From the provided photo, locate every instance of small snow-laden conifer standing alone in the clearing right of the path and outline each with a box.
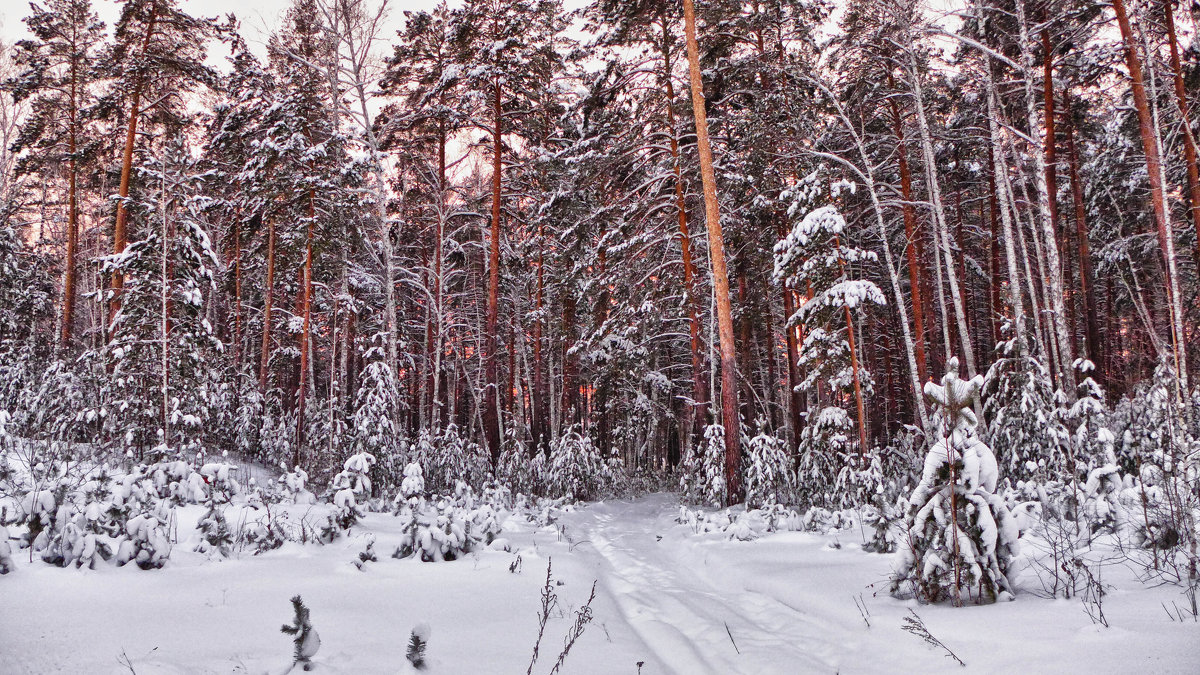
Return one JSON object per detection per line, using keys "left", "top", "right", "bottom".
{"left": 892, "top": 358, "right": 1019, "bottom": 603}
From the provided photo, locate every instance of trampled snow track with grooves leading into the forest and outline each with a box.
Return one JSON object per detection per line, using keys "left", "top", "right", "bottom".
{"left": 564, "top": 496, "right": 854, "bottom": 675}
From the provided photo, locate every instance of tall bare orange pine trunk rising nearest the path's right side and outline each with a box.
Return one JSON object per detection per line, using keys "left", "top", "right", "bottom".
{"left": 683, "top": 0, "right": 742, "bottom": 504}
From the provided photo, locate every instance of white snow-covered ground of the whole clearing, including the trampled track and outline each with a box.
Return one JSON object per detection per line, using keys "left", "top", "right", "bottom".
{"left": 0, "top": 495, "right": 1200, "bottom": 675}
